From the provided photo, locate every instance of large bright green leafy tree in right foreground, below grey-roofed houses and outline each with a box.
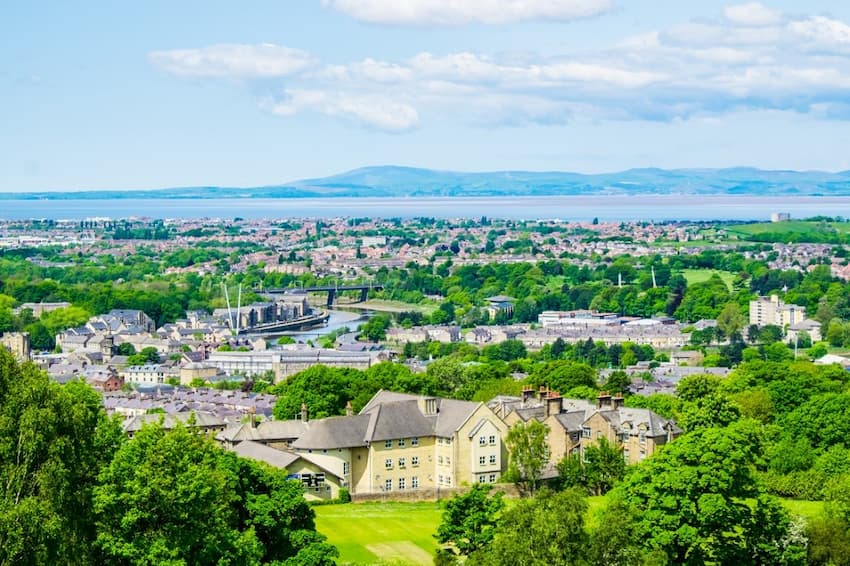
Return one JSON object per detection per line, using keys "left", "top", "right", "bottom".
{"left": 614, "top": 422, "right": 800, "bottom": 565}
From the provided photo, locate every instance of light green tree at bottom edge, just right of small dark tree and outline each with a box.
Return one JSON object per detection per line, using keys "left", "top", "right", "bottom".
{"left": 470, "top": 489, "right": 590, "bottom": 566}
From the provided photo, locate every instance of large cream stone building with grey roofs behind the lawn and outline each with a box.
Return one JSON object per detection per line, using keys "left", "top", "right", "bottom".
{"left": 292, "top": 391, "right": 507, "bottom": 494}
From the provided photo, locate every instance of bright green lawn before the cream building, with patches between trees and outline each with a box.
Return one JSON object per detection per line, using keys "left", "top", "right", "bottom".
{"left": 314, "top": 496, "right": 823, "bottom": 565}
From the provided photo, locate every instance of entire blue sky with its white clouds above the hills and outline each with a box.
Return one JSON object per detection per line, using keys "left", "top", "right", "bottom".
{"left": 0, "top": 0, "right": 850, "bottom": 191}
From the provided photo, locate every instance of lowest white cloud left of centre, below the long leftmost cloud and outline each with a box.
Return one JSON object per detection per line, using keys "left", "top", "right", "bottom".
{"left": 269, "top": 89, "right": 419, "bottom": 133}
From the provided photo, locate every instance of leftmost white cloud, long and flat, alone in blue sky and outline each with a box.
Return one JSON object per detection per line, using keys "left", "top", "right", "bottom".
{"left": 150, "top": 44, "right": 315, "bottom": 79}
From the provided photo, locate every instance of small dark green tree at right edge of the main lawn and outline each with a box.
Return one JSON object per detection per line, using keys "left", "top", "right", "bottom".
{"left": 434, "top": 483, "right": 505, "bottom": 556}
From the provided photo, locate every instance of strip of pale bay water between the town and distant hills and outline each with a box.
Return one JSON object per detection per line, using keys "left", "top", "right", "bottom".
{"left": 0, "top": 195, "right": 850, "bottom": 222}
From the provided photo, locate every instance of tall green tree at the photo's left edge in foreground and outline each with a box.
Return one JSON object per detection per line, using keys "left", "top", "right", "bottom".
{"left": 0, "top": 347, "right": 124, "bottom": 565}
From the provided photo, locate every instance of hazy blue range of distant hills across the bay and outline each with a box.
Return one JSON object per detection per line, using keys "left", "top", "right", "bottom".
{"left": 0, "top": 166, "right": 850, "bottom": 200}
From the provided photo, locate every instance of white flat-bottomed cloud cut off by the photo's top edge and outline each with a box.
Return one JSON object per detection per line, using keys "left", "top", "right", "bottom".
{"left": 322, "top": 0, "right": 613, "bottom": 26}
